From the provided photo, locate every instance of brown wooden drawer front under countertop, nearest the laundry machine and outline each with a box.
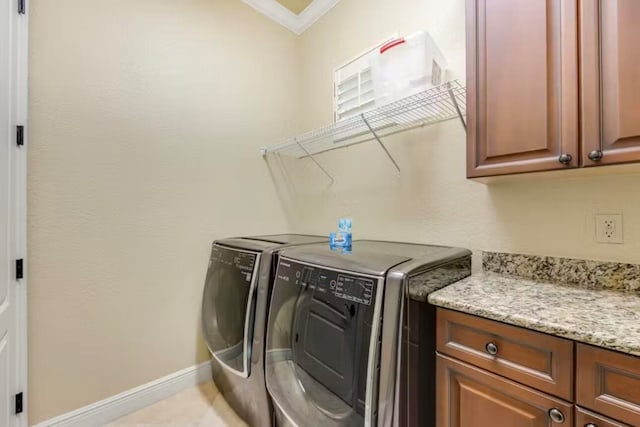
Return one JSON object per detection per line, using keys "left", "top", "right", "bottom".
{"left": 437, "top": 309, "right": 574, "bottom": 401}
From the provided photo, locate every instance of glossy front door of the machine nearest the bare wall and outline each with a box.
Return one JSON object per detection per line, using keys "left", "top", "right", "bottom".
{"left": 202, "top": 244, "right": 260, "bottom": 378}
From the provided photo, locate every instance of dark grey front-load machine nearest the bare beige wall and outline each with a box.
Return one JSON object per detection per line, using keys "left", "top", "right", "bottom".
{"left": 202, "top": 234, "right": 328, "bottom": 426}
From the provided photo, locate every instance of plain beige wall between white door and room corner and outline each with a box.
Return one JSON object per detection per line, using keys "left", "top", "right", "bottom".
{"left": 28, "top": 0, "right": 297, "bottom": 423}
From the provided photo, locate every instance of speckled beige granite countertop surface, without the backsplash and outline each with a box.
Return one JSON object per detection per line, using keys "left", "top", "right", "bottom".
{"left": 428, "top": 272, "right": 640, "bottom": 356}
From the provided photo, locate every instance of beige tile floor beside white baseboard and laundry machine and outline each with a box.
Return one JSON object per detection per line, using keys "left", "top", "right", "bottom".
{"left": 107, "top": 382, "right": 247, "bottom": 427}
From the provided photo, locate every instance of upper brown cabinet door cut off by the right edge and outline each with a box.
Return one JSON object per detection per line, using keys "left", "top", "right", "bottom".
{"left": 580, "top": 0, "right": 640, "bottom": 166}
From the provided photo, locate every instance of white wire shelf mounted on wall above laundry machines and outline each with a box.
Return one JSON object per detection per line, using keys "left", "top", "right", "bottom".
{"left": 262, "top": 80, "right": 466, "bottom": 160}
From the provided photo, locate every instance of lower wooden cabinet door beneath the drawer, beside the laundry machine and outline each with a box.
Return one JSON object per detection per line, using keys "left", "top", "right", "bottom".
{"left": 436, "top": 354, "right": 573, "bottom": 427}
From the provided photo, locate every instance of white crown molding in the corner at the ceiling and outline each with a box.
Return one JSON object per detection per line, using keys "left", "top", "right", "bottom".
{"left": 242, "top": 0, "right": 340, "bottom": 35}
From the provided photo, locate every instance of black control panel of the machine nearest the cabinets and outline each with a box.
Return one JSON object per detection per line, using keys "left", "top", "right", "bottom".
{"left": 277, "top": 258, "right": 376, "bottom": 305}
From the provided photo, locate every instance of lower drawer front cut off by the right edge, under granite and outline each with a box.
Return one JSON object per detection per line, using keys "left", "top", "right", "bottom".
{"left": 576, "top": 344, "right": 640, "bottom": 426}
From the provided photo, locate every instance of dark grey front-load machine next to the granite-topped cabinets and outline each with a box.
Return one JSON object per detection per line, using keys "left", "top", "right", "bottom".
{"left": 265, "top": 241, "right": 471, "bottom": 426}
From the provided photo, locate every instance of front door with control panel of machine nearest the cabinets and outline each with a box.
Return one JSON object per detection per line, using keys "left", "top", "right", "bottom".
{"left": 265, "top": 258, "right": 384, "bottom": 427}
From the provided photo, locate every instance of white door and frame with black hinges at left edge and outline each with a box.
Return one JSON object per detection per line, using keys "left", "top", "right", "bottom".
{"left": 0, "top": 0, "right": 26, "bottom": 427}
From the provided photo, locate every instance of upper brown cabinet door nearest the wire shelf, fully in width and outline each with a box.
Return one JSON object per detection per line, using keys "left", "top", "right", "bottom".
{"left": 466, "top": 0, "right": 579, "bottom": 177}
